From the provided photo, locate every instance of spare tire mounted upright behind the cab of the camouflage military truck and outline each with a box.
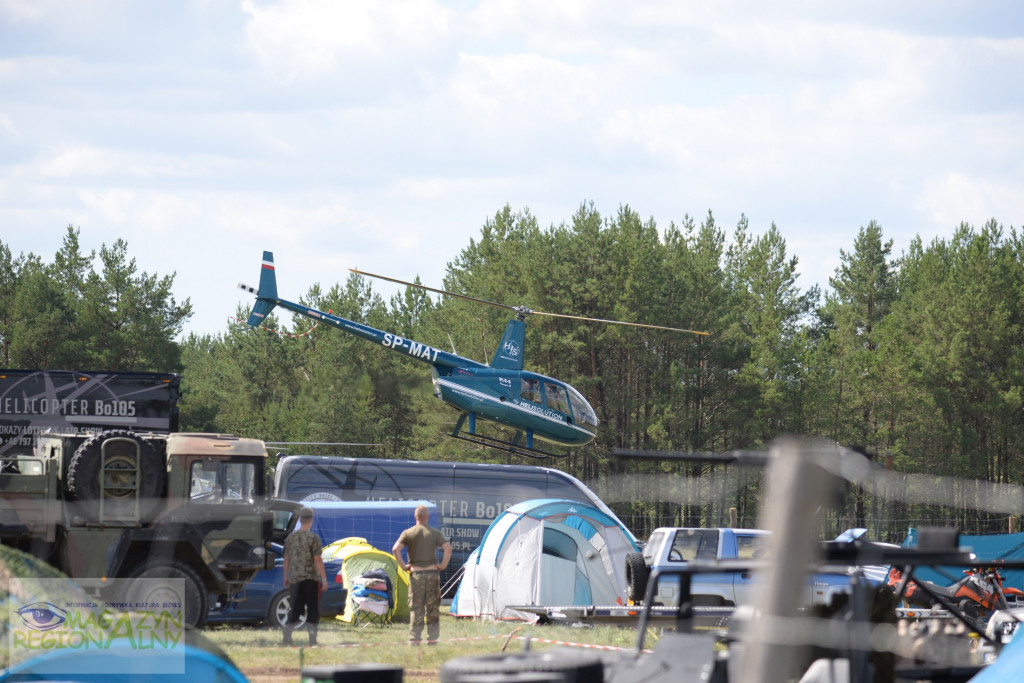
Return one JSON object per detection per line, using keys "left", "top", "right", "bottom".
{"left": 68, "top": 429, "right": 166, "bottom": 521}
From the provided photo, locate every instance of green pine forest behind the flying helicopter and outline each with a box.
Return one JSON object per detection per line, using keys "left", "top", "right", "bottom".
{"left": 0, "top": 204, "right": 1024, "bottom": 542}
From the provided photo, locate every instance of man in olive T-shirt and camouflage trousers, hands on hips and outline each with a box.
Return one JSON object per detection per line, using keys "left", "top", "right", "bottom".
{"left": 391, "top": 505, "right": 452, "bottom": 645}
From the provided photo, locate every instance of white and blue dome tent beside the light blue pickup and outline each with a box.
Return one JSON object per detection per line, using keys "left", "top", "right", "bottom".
{"left": 450, "top": 499, "right": 637, "bottom": 618}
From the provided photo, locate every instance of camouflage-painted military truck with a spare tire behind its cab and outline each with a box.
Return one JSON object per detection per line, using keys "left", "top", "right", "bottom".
{"left": 0, "top": 429, "right": 301, "bottom": 626}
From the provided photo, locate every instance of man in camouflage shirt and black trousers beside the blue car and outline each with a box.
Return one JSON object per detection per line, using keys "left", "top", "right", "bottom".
{"left": 284, "top": 508, "right": 327, "bottom": 645}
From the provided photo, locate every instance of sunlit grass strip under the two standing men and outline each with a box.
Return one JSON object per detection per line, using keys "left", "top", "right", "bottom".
{"left": 204, "top": 614, "right": 653, "bottom": 683}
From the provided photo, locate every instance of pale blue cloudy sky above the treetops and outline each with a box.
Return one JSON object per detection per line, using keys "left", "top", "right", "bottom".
{"left": 0, "top": 0, "right": 1024, "bottom": 333}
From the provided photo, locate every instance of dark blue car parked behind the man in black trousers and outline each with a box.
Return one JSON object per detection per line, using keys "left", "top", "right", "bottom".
{"left": 207, "top": 554, "right": 348, "bottom": 629}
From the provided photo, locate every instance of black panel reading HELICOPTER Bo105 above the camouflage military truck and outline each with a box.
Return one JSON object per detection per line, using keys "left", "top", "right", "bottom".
{"left": 0, "top": 370, "right": 180, "bottom": 456}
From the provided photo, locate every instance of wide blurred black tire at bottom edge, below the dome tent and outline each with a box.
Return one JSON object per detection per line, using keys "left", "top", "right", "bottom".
{"left": 440, "top": 649, "right": 604, "bottom": 683}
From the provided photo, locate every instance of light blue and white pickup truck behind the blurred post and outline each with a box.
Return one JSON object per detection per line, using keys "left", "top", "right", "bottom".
{"left": 626, "top": 526, "right": 876, "bottom": 606}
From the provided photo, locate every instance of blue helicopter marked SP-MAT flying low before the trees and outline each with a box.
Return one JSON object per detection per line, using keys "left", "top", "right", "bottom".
{"left": 239, "top": 251, "right": 708, "bottom": 458}
